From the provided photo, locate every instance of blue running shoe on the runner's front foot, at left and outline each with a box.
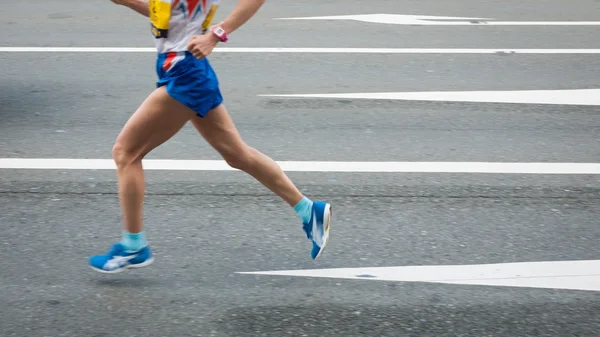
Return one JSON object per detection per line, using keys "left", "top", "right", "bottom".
{"left": 90, "top": 243, "right": 154, "bottom": 274}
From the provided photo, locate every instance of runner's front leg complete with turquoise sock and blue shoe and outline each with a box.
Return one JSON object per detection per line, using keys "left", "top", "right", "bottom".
{"left": 89, "top": 87, "right": 194, "bottom": 273}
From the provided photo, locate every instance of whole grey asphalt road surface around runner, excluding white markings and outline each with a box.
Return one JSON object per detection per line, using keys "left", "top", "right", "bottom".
{"left": 0, "top": 0, "right": 600, "bottom": 337}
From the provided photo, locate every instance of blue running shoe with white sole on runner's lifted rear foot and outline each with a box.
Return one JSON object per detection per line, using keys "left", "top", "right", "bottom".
{"left": 302, "top": 201, "right": 332, "bottom": 260}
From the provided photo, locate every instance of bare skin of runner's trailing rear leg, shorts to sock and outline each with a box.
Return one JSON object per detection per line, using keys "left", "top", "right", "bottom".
{"left": 192, "top": 104, "right": 303, "bottom": 207}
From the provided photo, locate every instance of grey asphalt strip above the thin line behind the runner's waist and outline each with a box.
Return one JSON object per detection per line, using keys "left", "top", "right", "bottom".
{"left": 0, "top": 0, "right": 600, "bottom": 48}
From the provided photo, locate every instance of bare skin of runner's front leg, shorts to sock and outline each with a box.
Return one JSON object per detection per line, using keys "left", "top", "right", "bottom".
{"left": 113, "top": 87, "right": 195, "bottom": 233}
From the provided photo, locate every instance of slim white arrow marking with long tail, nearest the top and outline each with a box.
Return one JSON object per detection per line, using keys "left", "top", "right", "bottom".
{"left": 276, "top": 14, "right": 600, "bottom": 26}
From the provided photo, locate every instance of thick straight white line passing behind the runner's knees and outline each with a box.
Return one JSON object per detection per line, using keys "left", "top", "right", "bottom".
{"left": 0, "top": 158, "right": 600, "bottom": 175}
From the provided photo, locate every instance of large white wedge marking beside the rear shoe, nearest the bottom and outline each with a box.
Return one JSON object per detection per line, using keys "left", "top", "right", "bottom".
{"left": 239, "top": 260, "right": 600, "bottom": 291}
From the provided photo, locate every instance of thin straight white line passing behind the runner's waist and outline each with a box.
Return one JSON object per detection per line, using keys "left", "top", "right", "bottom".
{"left": 0, "top": 47, "right": 600, "bottom": 54}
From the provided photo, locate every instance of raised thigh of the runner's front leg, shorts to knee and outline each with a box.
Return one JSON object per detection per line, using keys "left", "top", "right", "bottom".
{"left": 115, "top": 87, "right": 195, "bottom": 158}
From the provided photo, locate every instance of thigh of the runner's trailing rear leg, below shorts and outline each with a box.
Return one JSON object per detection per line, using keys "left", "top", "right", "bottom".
{"left": 192, "top": 104, "right": 246, "bottom": 154}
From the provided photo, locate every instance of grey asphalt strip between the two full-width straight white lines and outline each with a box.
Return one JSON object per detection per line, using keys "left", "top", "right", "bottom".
{"left": 0, "top": 53, "right": 600, "bottom": 162}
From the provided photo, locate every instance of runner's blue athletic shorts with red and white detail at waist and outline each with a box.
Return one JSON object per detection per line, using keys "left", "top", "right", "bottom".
{"left": 156, "top": 51, "right": 223, "bottom": 117}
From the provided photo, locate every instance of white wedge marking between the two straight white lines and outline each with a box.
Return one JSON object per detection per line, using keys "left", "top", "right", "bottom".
{"left": 260, "top": 89, "right": 600, "bottom": 105}
